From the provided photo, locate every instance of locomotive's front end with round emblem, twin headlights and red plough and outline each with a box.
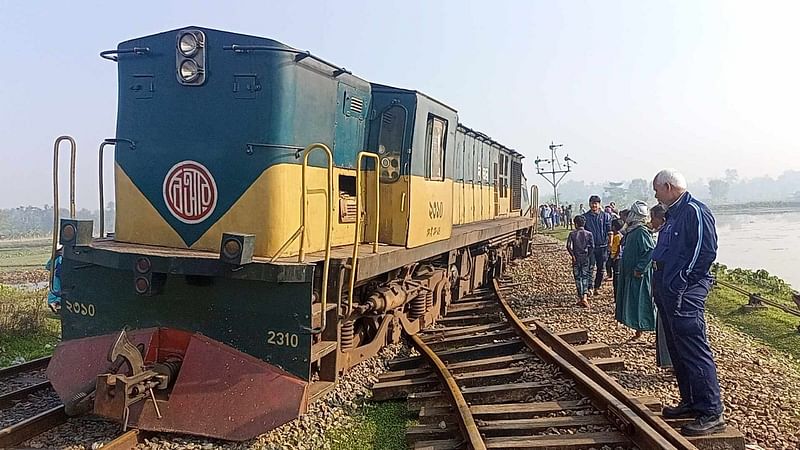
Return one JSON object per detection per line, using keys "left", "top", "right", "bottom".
{"left": 48, "top": 27, "right": 352, "bottom": 440}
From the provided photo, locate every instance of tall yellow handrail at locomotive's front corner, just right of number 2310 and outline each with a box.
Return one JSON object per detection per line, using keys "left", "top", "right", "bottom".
{"left": 270, "top": 142, "right": 333, "bottom": 334}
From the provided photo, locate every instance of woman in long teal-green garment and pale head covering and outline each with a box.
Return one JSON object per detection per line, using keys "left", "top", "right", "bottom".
{"left": 616, "top": 201, "right": 656, "bottom": 339}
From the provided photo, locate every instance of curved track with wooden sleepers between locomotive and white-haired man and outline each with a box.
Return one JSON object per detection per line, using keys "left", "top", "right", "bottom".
{"left": 373, "top": 281, "right": 744, "bottom": 450}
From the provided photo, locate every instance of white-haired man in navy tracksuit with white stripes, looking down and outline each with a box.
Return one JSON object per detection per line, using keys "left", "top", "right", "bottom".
{"left": 653, "top": 169, "right": 725, "bottom": 436}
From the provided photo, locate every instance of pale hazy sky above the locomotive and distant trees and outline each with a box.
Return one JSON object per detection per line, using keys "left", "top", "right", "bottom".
{"left": 0, "top": 0, "right": 800, "bottom": 209}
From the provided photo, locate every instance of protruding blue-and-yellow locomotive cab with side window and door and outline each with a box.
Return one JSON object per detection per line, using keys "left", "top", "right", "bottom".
{"left": 368, "top": 84, "right": 458, "bottom": 248}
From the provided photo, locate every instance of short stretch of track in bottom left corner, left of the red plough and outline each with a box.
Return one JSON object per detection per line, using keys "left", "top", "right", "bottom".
{"left": 0, "top": 357, "right": 67, "bottom": 448}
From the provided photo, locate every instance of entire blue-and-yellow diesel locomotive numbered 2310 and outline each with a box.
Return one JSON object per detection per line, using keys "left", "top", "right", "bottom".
{"left": 42, "top": 26, "right": 534, "bottom": 440}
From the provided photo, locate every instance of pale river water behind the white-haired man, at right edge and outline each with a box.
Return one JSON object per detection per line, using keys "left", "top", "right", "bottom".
{"left": 714, "top": 209, "right": 800, "bottom": 290}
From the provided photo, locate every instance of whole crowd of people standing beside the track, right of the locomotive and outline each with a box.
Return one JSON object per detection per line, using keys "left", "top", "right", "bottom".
{"left": 564, "top": 169, "right": 725, "bottom": 436}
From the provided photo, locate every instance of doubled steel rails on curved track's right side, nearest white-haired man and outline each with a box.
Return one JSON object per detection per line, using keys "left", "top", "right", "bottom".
{"left": 493, "top": 280, "right": 697, "bottom": 450}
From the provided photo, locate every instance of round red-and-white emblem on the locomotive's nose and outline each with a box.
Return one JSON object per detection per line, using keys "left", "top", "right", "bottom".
{"left": 164, "top": 161, "right": 217, "bottom": 223}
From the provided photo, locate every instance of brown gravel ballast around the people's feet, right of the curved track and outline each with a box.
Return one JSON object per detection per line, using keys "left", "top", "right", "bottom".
{"left": 507, "top": 235, "right": 800, "bottom": 449}
